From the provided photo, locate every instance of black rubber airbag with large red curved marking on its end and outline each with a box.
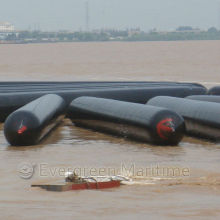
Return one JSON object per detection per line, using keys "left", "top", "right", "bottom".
{"left": 67, "top": 97, "right": 185, "bottom": 145}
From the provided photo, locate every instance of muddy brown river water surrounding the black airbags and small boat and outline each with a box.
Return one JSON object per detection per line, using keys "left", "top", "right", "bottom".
{"left": 0, "top": 41, "right": 220, "bottom": 220}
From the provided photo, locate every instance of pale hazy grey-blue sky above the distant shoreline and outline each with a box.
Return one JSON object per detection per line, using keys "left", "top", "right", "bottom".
{"left": 0, "top": 0, "right": 220, "bottom": 30}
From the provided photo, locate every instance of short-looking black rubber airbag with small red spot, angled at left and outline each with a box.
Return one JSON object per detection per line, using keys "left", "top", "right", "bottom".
{"left": 4, "top": 94, "right": 66, "bottom": 146}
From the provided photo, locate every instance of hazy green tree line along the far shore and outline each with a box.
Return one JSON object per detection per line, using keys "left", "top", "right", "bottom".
{"left": 5, "top": 26, "right": 220, "bottom": 43}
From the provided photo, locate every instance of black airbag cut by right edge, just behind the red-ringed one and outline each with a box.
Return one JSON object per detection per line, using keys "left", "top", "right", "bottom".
{"left": 147, "top": 96, "right": 220, "bottom": 140}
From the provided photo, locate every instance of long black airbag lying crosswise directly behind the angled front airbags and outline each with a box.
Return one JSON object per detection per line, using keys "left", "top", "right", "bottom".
{"left": 0, "top": 85, "right": 206, "bottom": 122}
